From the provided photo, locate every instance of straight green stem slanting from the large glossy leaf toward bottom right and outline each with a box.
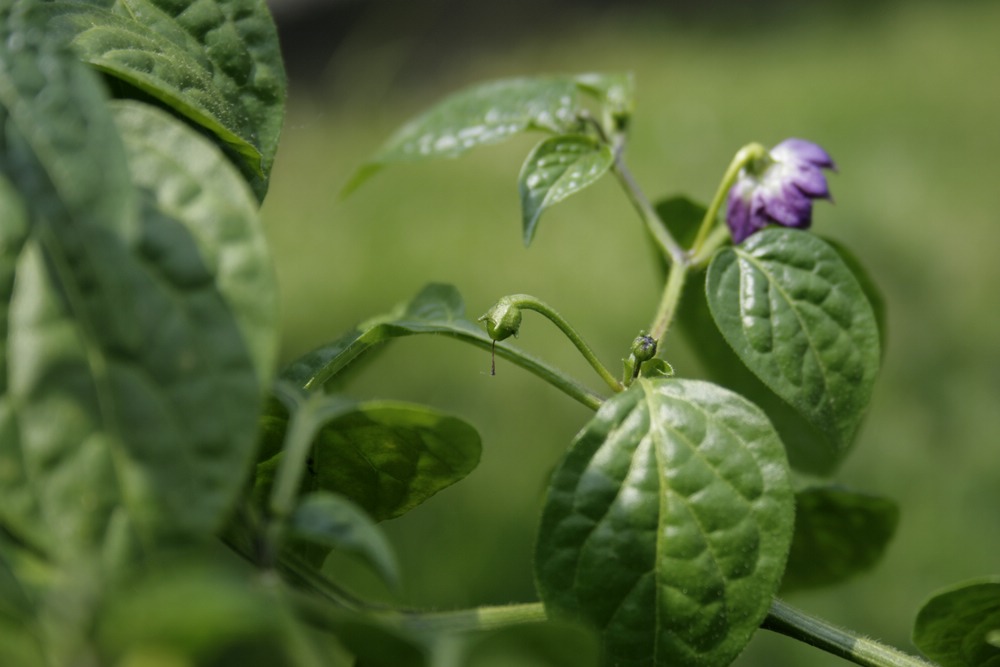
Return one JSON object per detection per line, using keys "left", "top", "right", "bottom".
{"left": 761, "top": 598, "right": 935, "bottom": 667}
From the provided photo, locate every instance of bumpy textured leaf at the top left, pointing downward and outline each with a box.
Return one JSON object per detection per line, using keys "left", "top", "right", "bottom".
{"left": 46, "top": 0, "right": 285, "bottom": 199}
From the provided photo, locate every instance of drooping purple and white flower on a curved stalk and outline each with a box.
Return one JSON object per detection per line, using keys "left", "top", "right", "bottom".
{"left": 726, "top": 139, "right": 836, "bottom": 243}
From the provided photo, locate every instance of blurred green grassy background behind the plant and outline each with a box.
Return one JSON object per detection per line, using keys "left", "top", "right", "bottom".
{"left": 264, "top": 0, "right": 1000, "bottom": 666}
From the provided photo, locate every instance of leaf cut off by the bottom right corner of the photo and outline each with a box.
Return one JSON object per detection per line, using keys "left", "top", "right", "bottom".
{"left": 913, "top": 577, "right": 1000, "bottom": 667}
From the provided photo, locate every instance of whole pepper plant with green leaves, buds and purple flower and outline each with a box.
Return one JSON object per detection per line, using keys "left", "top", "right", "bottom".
{"left": 0, "top": 0, "right": 1000, "bottom": 667}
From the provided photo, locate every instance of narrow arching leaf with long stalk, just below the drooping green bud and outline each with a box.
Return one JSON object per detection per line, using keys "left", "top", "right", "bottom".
{"left": 281, "top": 283, "right": 601, "bottom": 407}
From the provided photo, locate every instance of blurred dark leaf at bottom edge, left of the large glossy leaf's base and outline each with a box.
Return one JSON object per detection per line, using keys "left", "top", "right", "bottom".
{"left": 462, "top": 621, "right": 600, "bottom": 667}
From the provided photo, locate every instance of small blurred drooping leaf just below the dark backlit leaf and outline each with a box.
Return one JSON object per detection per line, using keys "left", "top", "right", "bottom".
{"left": 288, "top": 491, "right": 399, "bottom": 587}
